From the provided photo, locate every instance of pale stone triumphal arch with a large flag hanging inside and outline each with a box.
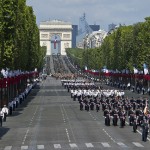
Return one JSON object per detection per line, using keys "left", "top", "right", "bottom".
{"left": 39, "top": 20, "right": 72, "bottom": 56}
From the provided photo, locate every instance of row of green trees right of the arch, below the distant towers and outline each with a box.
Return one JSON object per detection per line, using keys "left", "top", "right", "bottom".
{"left": 67, "top": 17, "right": 150, "bottom": 70}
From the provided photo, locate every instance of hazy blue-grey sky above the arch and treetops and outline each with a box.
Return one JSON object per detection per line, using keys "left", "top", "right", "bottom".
{"left": 26, "top": 0, "right": 150, "bottom": 30}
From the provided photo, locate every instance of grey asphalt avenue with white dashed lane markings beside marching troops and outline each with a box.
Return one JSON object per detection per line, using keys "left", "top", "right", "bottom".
{"left": 0, "top": 77, "right": 150, "bottom": 150}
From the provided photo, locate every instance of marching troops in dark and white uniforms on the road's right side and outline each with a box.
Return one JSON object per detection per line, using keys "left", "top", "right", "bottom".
{"left": 61, "top": 80, "right": 150, "bottom": 141}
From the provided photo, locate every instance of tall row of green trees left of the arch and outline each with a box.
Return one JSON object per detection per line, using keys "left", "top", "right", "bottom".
{"left": 0, "top": 0, "right": 46, "bottom": 71}
